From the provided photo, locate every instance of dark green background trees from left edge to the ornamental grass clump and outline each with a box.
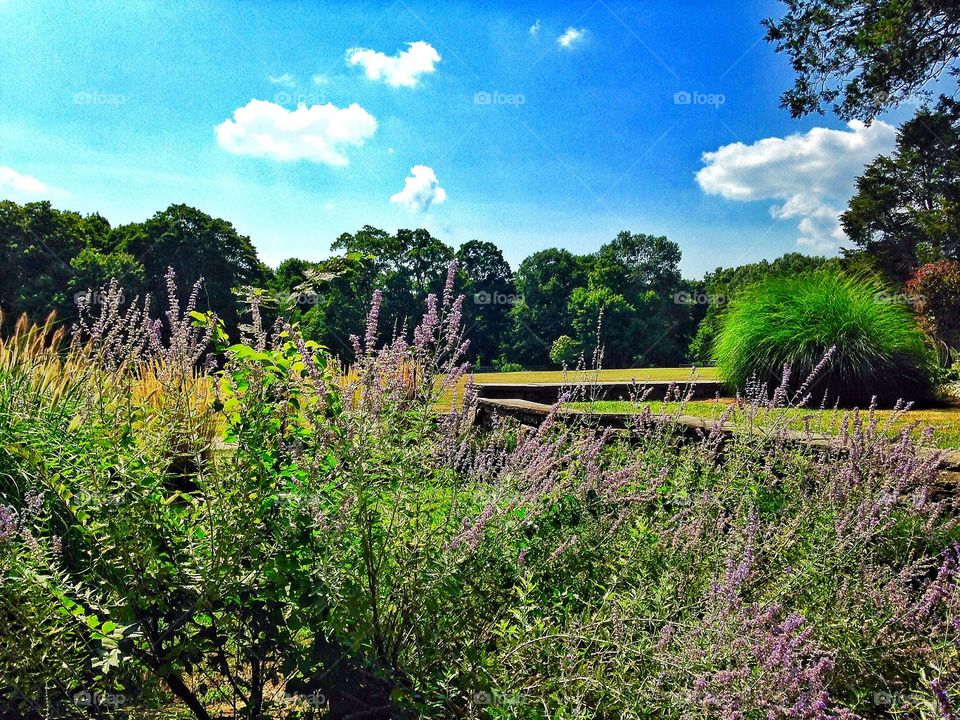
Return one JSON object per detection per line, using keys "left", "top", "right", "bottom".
{"left": 0, "top": 195, "right": 704, "bottom": 367}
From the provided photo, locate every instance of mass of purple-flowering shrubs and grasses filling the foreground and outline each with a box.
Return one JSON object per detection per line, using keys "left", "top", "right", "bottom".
{"left": 0, "top": 269, "right": 960, "bottom": 719}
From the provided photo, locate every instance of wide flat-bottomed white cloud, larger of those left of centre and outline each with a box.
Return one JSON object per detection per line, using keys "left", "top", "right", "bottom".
{"left": 214, "top": 100, "right": 377, "bottom": 165}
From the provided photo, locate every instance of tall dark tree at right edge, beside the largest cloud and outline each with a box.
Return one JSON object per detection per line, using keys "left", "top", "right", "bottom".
{"left": 840, "top": 98, "right": 960, "bottom": 282}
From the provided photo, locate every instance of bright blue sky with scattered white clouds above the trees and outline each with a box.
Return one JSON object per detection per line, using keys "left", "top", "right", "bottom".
{"left": 0, "top": 0, "right": 915, "bottom": 279}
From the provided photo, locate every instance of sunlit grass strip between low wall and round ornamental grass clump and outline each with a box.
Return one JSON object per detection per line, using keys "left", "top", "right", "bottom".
{"left": 570, "top": 398, "right": 960, "bottom": 450}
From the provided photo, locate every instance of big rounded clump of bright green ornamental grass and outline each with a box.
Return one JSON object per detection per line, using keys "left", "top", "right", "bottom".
{"left": 713, "top": 270, "right": 935, "bottom": 407}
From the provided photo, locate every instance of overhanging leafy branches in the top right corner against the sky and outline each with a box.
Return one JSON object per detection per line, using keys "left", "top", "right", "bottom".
{"left": 764, "top": 0, "right": 960, "bottom": 120}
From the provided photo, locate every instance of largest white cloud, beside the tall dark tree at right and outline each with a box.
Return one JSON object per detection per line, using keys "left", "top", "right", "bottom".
{"left": 696, "top": 120, "right": 896, "bottom": 252}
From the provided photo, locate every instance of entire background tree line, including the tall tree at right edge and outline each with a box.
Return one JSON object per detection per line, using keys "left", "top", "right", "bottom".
{"left": 0, "top": 97, "right": 960, "bottom": 369}
